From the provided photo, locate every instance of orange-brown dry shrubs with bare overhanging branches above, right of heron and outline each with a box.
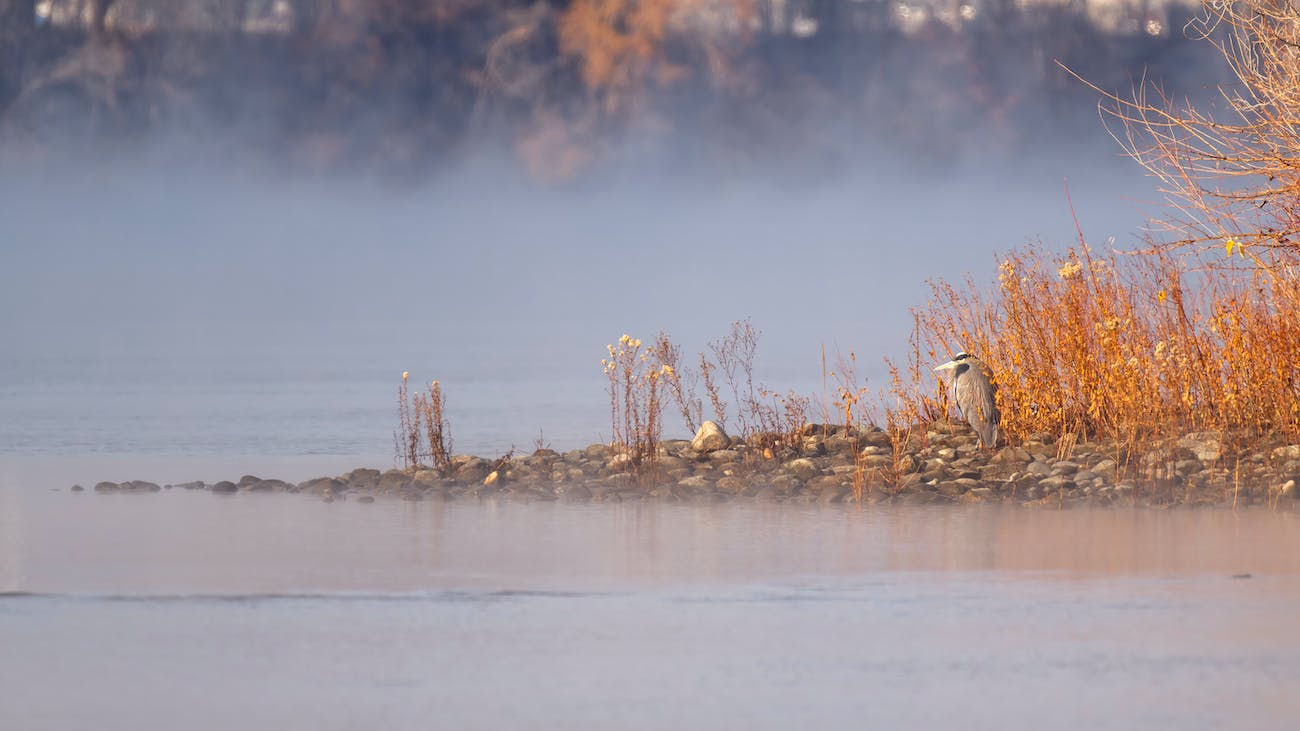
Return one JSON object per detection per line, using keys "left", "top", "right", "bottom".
{"left": 896, "top": 1, "right": 1300, "bottom": 476}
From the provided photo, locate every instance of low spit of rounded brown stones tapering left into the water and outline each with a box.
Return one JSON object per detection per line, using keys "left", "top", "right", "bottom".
{"left": 83, "top": 421, "right": 1300, "bottom": 510}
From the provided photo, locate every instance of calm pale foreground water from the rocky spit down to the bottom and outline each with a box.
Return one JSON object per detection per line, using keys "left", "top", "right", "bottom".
{"left": 0, "top": 460, "right": 1300, "bottom": 728}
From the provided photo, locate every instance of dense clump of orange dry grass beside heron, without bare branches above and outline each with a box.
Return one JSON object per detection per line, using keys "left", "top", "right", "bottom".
{"left": 896, "top": 232, "right": 1300, "bottom": 463}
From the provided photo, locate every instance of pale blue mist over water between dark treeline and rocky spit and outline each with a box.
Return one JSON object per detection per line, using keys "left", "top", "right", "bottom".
{"left": 0, "top": 155, "right": 1153, "bottom": 455}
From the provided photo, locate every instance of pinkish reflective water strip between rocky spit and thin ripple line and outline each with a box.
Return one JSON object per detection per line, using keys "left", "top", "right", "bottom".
{"left": 0, "top": 488, "right": 1300, "bottom": 593}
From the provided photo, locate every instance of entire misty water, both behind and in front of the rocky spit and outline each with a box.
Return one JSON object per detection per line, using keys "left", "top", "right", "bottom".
{"left": 0, "top": 161, "right": 1284, "bottom": 731}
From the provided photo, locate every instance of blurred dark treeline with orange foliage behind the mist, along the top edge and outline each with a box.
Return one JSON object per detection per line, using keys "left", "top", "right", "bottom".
{"left": 0, "top": 0, "right": 1221, "bottom": 181}
